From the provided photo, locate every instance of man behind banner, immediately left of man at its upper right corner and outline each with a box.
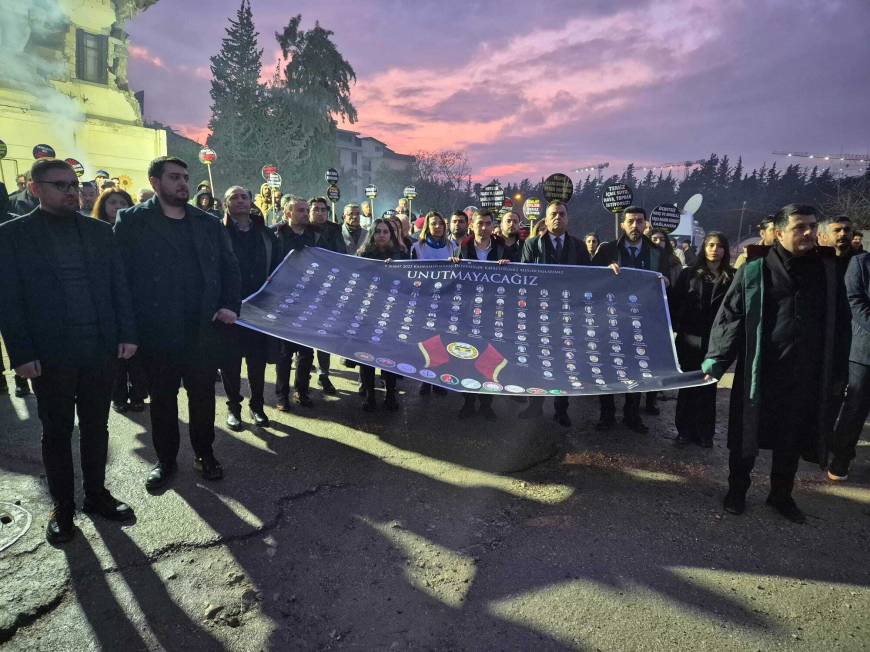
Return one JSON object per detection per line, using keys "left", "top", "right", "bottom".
{"left": 519, "top": 199, "right": 591, "bottom": 427}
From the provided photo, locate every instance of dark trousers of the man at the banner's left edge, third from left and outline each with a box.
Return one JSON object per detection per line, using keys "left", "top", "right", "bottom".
{"left": 221, "top": 326, "right": 268, "bottom": 413}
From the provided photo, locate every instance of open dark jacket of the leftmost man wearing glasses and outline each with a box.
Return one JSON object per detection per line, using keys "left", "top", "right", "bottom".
{"left": 0, "top": 210, "right": 138, "bottom": 367}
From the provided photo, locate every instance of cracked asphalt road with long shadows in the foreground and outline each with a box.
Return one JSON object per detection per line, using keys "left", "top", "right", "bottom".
{"left": 0, "top": 361, "right": 870, "bottom": 652}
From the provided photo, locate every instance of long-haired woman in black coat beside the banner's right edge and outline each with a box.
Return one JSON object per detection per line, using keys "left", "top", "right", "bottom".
{"left": 671, "top": 232, "right": 734, "bottom": 448}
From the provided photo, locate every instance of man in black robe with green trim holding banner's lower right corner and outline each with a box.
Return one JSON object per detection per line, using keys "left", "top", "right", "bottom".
{"left": 701, "top": 204, "right": 849, "bottom": 523}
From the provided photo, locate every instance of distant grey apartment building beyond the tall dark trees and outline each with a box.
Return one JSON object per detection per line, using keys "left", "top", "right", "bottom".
{"left": 335, "top": 129, "right": 414, "bottom": 197}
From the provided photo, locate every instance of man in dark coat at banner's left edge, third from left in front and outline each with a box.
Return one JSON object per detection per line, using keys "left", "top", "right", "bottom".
{"left": 221, "top": 186, "right": 281, "bottom": 432}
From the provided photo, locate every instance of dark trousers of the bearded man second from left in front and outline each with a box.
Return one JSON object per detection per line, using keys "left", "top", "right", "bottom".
{"left": 137, "top": 353, "right": 216, "bottom": 465}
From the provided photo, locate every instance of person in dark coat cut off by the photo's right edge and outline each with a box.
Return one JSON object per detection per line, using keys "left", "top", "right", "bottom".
{"left": 828, "top": 253, "right": 870, "bottom": 482}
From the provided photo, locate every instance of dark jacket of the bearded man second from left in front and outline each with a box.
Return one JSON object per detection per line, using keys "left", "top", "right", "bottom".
{"left": 115, "top": 197, "right": 241, "bottom": 355}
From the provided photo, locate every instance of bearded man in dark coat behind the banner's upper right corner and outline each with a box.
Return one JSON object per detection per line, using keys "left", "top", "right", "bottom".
{"left": 592, "top": 206, "right": 666, "bottom": 433}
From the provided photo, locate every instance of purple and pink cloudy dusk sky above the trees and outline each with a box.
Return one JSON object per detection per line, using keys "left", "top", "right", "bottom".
{"left": 127, "top": 0, "right": 870, "bottom": 181}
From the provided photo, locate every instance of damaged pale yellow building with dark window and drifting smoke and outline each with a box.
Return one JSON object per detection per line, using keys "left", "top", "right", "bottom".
{"left": 0, "top": 0, "right": 166, "bottom": 191}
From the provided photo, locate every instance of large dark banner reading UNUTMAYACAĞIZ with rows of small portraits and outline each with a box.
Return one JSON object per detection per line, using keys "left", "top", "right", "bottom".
{"left": 238, "top": 248, "right": 716, "bottom": 396}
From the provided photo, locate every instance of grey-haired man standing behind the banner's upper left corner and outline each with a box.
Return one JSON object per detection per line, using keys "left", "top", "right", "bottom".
{"left": 275, "top": 195, "right": 317, "bottom": 412}
